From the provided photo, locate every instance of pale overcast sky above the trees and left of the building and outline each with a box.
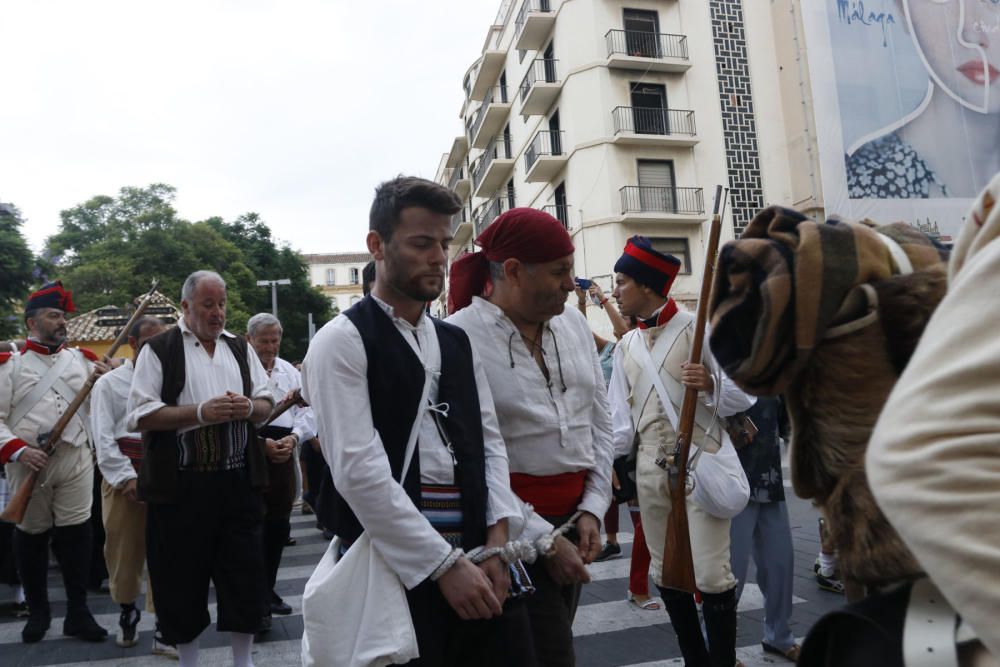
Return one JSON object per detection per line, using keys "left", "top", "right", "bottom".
{"left": 0, "top": 0, "right": 500, "bottom": 252}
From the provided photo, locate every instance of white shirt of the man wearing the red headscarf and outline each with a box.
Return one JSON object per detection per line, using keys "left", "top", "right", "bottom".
{"left": 446, "top": 297, "right": 614, "bottom": 542}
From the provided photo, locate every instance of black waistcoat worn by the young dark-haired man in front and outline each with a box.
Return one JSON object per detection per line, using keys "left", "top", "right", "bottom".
{"left": 326, "top": 297, "right": 487, "bottom": 549}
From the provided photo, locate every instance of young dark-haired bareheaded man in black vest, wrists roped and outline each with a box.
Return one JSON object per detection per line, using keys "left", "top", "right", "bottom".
{"left": 302, "top": 177, "right": 531, "bottom": 666}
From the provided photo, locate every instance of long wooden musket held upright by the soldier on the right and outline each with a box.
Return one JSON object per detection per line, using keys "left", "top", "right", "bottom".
{"left": 656, "top": 185, "right": 729, "bottom": 593}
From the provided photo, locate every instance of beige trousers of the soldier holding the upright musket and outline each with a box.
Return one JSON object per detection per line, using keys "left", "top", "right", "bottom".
{"left": 636, "top": 442, "right": 736, "bottom": 593}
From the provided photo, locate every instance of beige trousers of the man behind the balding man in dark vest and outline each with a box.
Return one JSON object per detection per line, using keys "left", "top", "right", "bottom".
{"left": 101, "top": 481, "right": 153, "bottom": 612}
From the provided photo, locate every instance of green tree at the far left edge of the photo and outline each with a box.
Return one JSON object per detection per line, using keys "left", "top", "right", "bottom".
{"left": 0, "top": 204, "right": 36, "bottom": 340}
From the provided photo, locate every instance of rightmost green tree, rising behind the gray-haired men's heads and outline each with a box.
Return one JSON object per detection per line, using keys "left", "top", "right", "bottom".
{"left": 205, "top": 213, "right": 332, "bottom": 361}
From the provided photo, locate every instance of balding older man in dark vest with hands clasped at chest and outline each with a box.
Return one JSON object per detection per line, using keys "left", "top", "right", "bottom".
{"left": 127, "top": 271, "right": 274, "bottom": 667}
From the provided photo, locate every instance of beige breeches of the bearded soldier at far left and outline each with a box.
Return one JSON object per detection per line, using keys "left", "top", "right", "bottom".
{"left": 6, "top": 444, "right": 94, "bottom": 535}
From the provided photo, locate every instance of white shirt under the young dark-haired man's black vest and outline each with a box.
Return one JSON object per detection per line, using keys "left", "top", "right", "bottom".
{"left": 302, "top": 299, "right": 521, "bottom": 588}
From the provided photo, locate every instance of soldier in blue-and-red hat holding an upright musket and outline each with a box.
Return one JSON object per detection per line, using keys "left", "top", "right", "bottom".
{"left": 608, "top": 236, "right": 753, "bottom": 667}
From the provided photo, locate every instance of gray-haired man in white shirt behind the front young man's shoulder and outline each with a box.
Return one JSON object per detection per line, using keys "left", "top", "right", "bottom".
{"left": 247, "top": 313, "right": 316, "bottom": 627}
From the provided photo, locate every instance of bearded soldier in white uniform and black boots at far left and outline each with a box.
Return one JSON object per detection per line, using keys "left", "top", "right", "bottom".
{"left": 0, "top": 281, "right": 108, "bottom": 643}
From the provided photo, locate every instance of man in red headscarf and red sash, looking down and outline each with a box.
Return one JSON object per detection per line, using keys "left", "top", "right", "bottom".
{"left": 448, "top": 208, "right": 614, "bottom": 666}
